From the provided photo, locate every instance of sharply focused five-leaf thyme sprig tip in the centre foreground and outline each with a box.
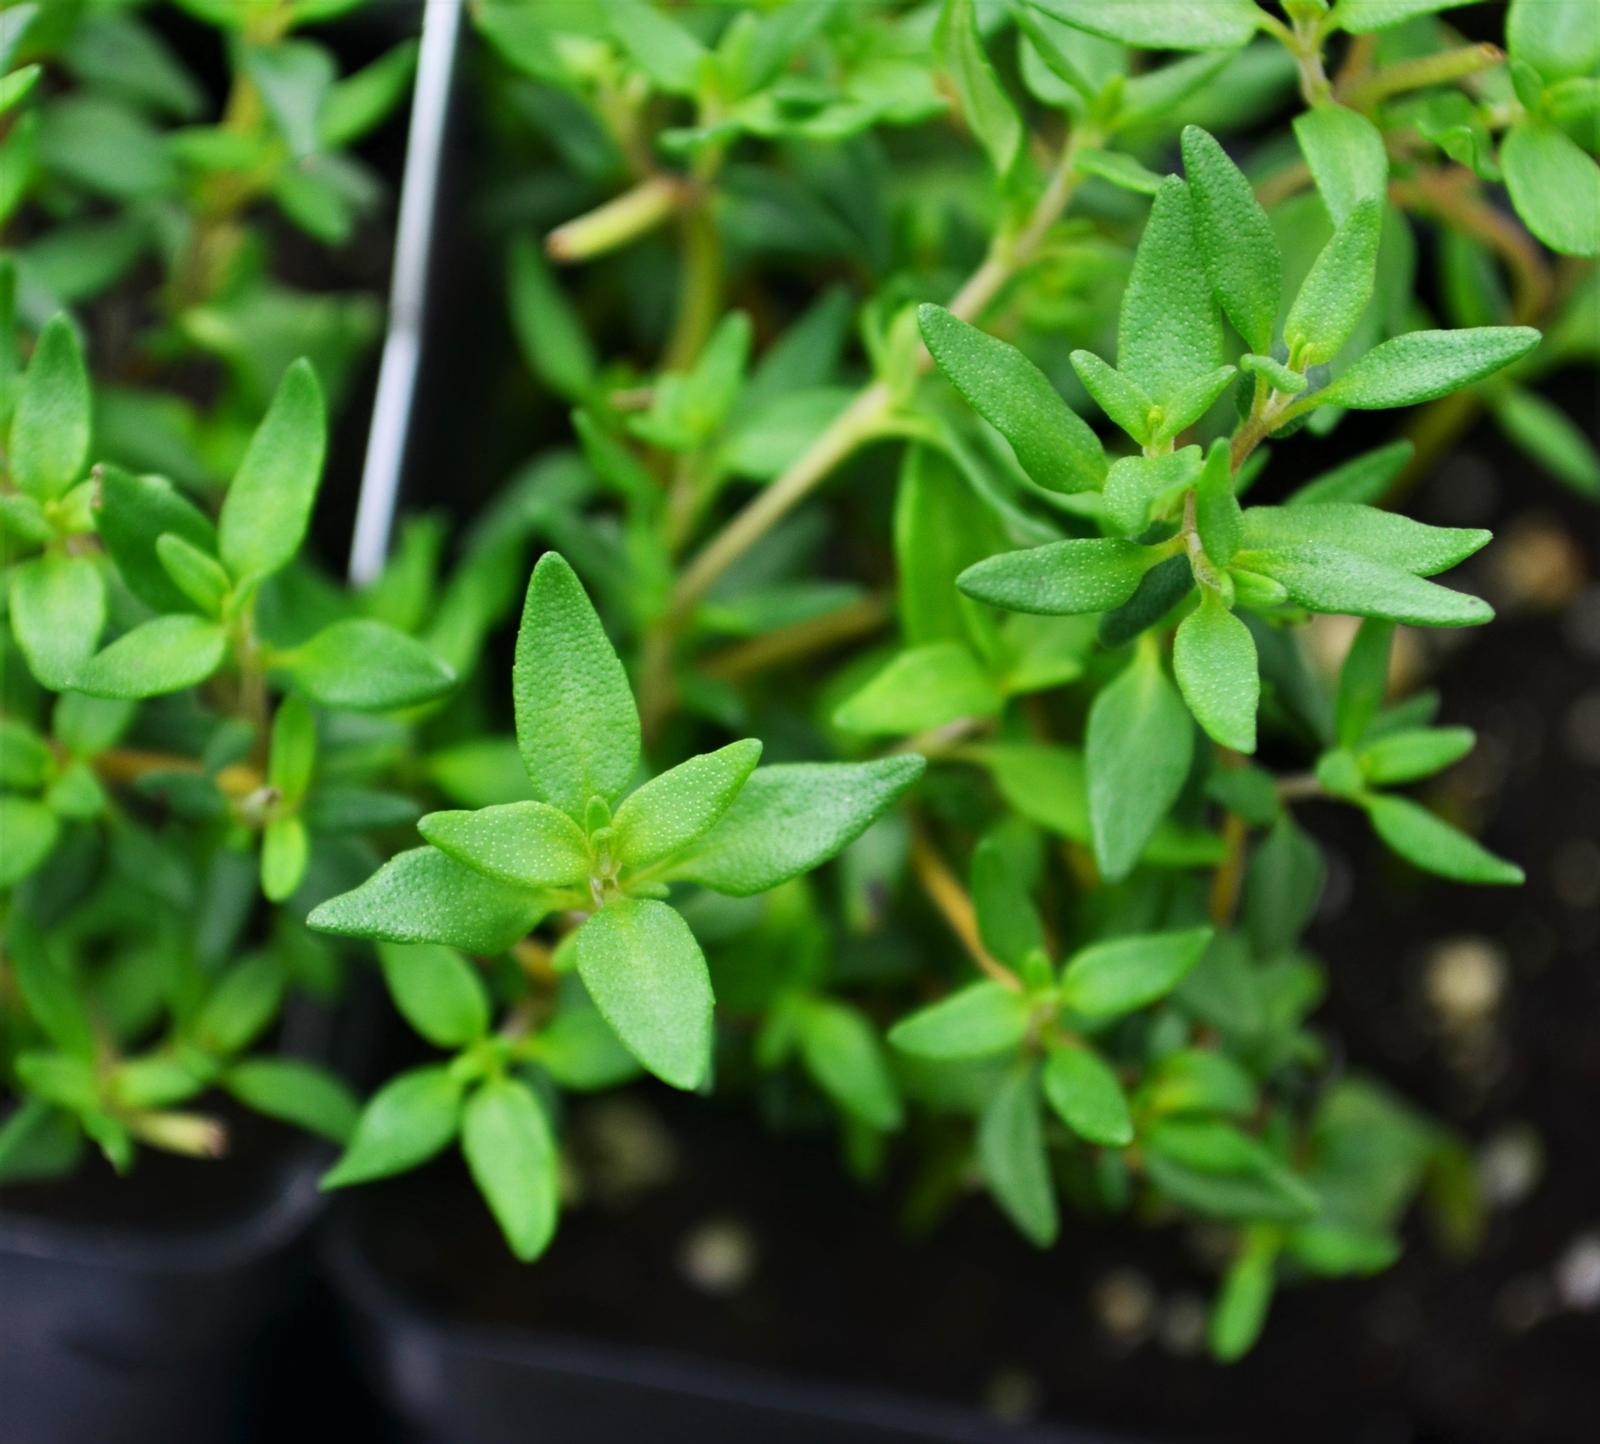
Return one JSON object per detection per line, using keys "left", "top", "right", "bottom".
{"left": 310, "top": 552, "right": 923, "bottom": 1089}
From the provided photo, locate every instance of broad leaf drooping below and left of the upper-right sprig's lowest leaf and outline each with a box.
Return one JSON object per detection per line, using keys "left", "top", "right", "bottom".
{"left": 1085, "top": 647, "right": 1194, "bottom": 882}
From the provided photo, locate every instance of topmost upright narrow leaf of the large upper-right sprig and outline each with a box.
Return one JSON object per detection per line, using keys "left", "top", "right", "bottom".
{"left": 1182, "top": 125, "right": 1283, "bottom": 354}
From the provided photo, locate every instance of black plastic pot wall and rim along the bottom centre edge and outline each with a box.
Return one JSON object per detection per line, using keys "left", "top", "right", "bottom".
{"left": 323, "top": 1212, "right": 1112, "bottom": 1444}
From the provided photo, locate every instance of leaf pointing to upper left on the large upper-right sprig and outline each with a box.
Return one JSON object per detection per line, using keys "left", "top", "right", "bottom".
{"left": 917, "top": 306, "right": 1106, "bottom": 491}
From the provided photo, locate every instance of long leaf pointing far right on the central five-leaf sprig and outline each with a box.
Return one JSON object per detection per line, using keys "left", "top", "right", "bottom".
{"left": 667, "top": 756, "right": 926, "bottom": 896}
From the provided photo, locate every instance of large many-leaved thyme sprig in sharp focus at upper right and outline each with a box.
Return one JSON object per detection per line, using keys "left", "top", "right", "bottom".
{"left": 920, "top": 126, "right": 1539, "bottom": 752}
